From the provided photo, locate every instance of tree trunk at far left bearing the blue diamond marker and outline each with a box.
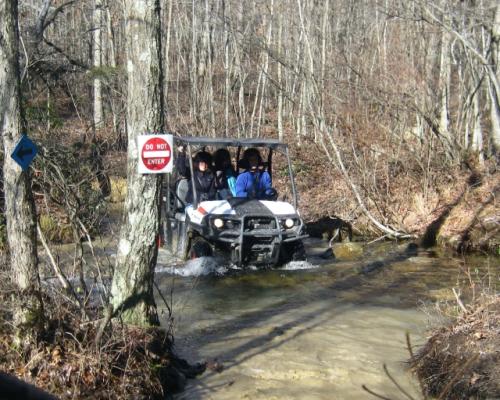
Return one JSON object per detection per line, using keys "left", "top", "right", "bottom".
{"left": 0, "top": 0, "right": 43, "bottom": 335}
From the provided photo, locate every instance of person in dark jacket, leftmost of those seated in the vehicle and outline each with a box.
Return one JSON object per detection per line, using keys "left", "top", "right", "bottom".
{"left": 186, "top": 151, "right": 216, "bottom": 203}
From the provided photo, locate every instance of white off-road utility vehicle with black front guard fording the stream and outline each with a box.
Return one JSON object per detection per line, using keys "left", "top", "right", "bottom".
{"left": 162, "top": 137, "right": 307, "bottom": 266}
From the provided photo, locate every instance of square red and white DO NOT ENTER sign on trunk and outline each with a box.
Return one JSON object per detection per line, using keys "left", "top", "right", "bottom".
{"left": 137, "top": 135, "right": 173, "bottom": 174}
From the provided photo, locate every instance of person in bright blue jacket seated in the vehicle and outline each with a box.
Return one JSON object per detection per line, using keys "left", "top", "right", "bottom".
{"left": 236, "top": 148, "right": 276, "bottom": 199}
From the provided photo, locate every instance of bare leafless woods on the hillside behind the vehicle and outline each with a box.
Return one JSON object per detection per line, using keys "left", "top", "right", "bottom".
{"left": 14, "top": 0, "right": 500, "bottom": 240}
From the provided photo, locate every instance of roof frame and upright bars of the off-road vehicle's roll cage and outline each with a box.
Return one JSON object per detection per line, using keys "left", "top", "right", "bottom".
{"left": 172, "top": 136, "right": 298, "bottom": 209}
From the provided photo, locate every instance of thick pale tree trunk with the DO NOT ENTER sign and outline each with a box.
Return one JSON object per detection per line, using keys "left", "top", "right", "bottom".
{"left": 111, "top": 0, "right": 164, "bottom": 326}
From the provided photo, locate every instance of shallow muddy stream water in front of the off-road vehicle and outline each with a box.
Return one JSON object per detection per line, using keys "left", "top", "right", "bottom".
{"left": 158, "top": 242, "right": 498, "bottom": 399}
